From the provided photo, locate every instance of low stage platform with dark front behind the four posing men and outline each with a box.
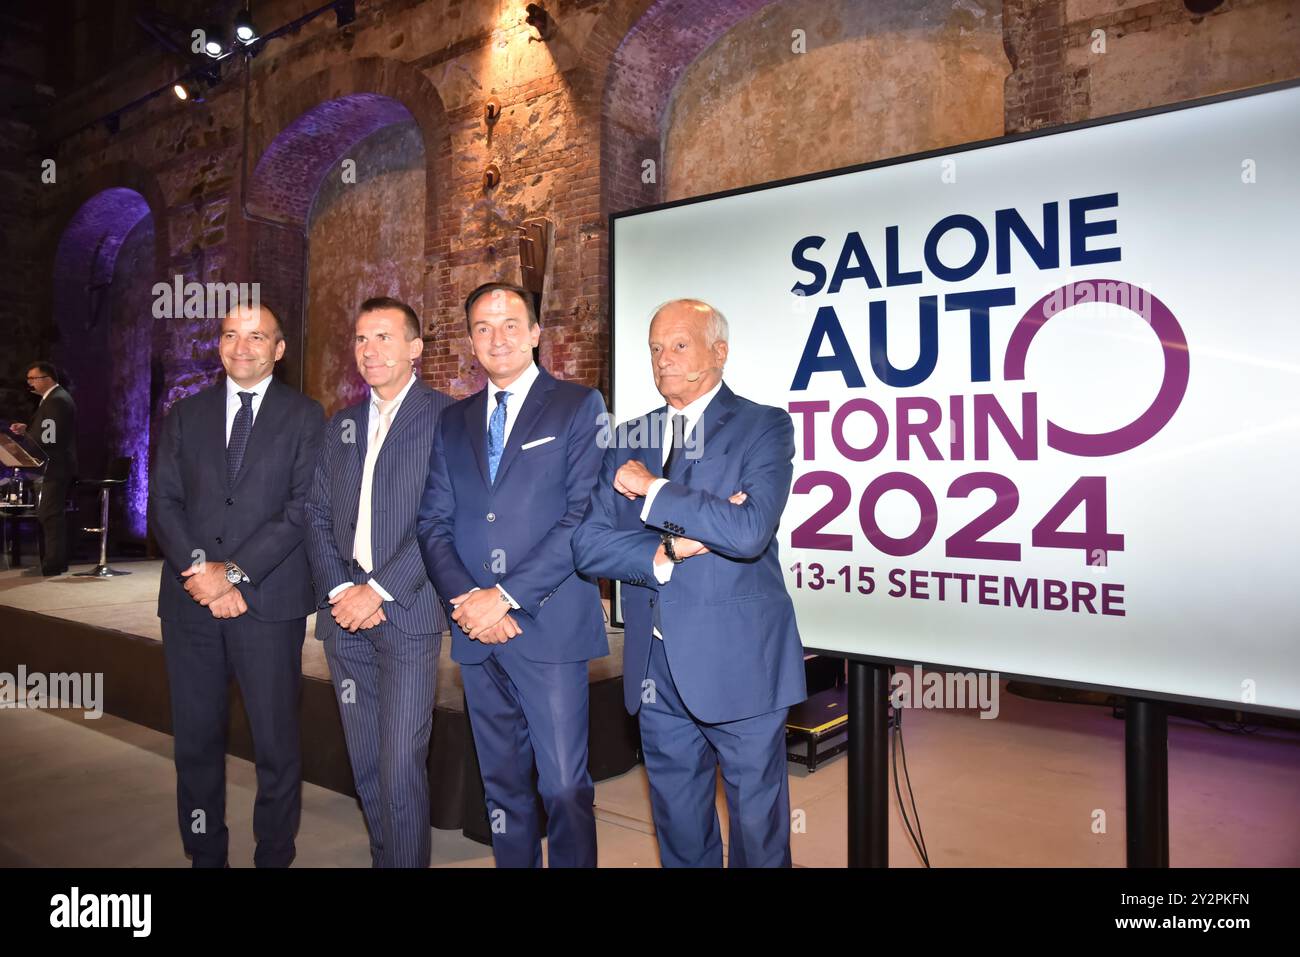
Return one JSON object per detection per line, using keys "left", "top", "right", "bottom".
{"left": 0, "top": 560, "right": 640, "bottom": 843}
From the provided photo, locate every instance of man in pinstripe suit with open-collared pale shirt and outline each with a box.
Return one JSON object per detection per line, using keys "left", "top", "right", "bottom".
{"left": 307, "top": 296, "right": 452, "bottom": 867}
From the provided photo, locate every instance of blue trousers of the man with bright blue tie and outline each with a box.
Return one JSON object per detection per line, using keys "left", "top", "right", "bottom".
{"left": 460, "top": 641, "right": 595, "bottom": 867}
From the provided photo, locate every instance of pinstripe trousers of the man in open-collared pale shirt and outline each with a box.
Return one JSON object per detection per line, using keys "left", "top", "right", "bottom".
{"left": 317, "top": 610, "right": 442, "bottom": 867}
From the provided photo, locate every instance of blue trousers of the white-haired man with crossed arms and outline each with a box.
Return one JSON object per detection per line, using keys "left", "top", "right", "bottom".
{"left": 640, "top": 640, "right": 790, "bottom": 867}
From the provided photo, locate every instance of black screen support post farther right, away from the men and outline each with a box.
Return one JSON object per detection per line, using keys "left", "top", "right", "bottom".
{"left": 1125, "top": 698, "right": 1169, "bottom": 867}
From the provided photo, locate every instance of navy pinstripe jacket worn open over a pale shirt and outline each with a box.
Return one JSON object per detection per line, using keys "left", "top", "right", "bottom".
{"left": 307, "top": 378, "right": 454, "bottom": 640}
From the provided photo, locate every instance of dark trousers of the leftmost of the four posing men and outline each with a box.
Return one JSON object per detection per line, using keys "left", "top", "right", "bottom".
{"left": 163, "top": 612, "right": 307, "bottom": 867}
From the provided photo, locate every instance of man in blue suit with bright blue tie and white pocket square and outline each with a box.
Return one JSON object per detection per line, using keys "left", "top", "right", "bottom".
{"left": 420, "top": 282, "right": 610, "bottom": 867}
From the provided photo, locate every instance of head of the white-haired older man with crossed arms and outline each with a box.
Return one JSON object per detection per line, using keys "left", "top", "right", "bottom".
{"left": 650, "top": 299, "right": 728, "bottom": 408}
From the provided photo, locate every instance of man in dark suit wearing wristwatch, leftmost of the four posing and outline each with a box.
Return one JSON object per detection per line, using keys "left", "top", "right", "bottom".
{"left": 150, "top": 307, "right": 325, "bottom": 867}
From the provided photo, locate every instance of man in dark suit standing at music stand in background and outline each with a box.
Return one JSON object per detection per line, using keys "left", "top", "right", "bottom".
{"left": 10, "top": 361, "right": 77, "bottom": 576}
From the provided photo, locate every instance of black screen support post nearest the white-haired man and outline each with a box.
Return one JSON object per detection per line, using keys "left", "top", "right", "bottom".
{"left": 849, "top": 661, "right": 889, "bottom": 867}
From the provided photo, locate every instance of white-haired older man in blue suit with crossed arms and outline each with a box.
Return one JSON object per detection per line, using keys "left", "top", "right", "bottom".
{"left": 573, "top": 299, "right": 807, "bottom": 867}
